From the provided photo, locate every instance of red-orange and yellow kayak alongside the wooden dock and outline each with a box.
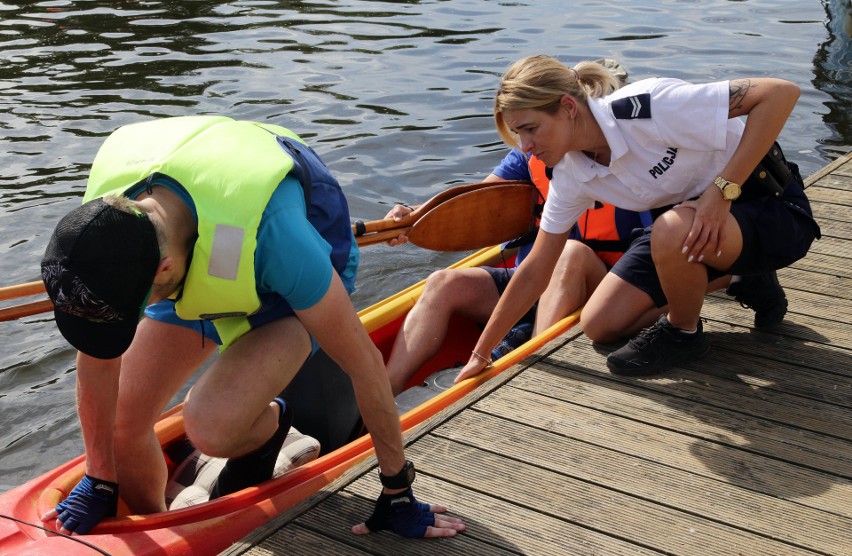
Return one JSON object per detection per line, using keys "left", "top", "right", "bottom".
{"left": 0, "top": 248, "right": 579, "bottom": 556}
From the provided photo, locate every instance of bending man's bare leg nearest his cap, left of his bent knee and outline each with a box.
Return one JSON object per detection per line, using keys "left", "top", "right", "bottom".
{"left": 115, "top": 319, "right": 216, "bottom": 514}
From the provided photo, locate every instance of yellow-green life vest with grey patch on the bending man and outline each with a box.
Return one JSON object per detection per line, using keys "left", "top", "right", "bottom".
{"left": 83, "top": 116, "right": 304, "bottom": 346}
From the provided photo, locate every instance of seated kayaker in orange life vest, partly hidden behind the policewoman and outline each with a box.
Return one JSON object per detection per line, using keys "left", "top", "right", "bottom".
{"left": 387, "top": 149, "right": 651, "bottom": 395}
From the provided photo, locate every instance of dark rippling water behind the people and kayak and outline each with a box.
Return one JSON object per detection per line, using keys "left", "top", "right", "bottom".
{"left": 0, "top": 0, "right": 852, "bottom": 489}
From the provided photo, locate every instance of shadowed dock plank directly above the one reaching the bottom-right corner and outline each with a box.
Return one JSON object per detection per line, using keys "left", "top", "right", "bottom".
{"left": 474, "top": 378, "right": 852, "bottom": 517}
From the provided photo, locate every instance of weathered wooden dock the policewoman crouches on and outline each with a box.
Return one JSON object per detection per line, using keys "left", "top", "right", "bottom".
{"left": 226, "top": 154, "right": 852, "bottom": 556}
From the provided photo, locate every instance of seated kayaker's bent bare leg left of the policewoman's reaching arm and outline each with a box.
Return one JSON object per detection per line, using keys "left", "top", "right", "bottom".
{"left": 387, "top": 268, "right": 500, "bottom": 395}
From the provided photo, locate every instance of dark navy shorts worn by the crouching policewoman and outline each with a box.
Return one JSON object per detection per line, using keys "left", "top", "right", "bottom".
{"left": 612, "top": 164, "right": 820, "bottom": 307}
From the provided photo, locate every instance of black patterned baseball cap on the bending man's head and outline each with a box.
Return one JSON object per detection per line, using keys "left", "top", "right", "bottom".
{"left": 41, "top": 199, "right": 160, "bottom": 359}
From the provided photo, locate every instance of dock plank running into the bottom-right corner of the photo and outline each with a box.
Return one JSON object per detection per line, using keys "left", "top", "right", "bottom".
{"left": 432, "top": 412, "right": 852, "bottom": 554}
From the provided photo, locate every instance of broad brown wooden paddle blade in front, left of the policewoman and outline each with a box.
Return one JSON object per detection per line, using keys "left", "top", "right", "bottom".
{"left": 408, "top": 183, "right": 538, "bottom": 251}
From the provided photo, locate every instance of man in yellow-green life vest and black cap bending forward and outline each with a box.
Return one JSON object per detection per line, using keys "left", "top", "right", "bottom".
{"left": 42, "top": 116, "right": 464, "bottom": 537}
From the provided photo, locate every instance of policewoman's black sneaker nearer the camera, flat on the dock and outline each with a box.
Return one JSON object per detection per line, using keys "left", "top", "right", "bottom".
{"left": 606, "top": 315, "right": 710, "bottom": 376}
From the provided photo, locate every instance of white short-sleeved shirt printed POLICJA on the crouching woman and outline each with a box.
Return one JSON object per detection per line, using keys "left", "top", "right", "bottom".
{"left": 541, "top": 79, "right": 744, "bottom": 234}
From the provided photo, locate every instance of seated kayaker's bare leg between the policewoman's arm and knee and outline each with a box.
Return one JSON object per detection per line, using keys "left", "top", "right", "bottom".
{"left": 533, "top": 240, "right": 607, "bottom": 334}
